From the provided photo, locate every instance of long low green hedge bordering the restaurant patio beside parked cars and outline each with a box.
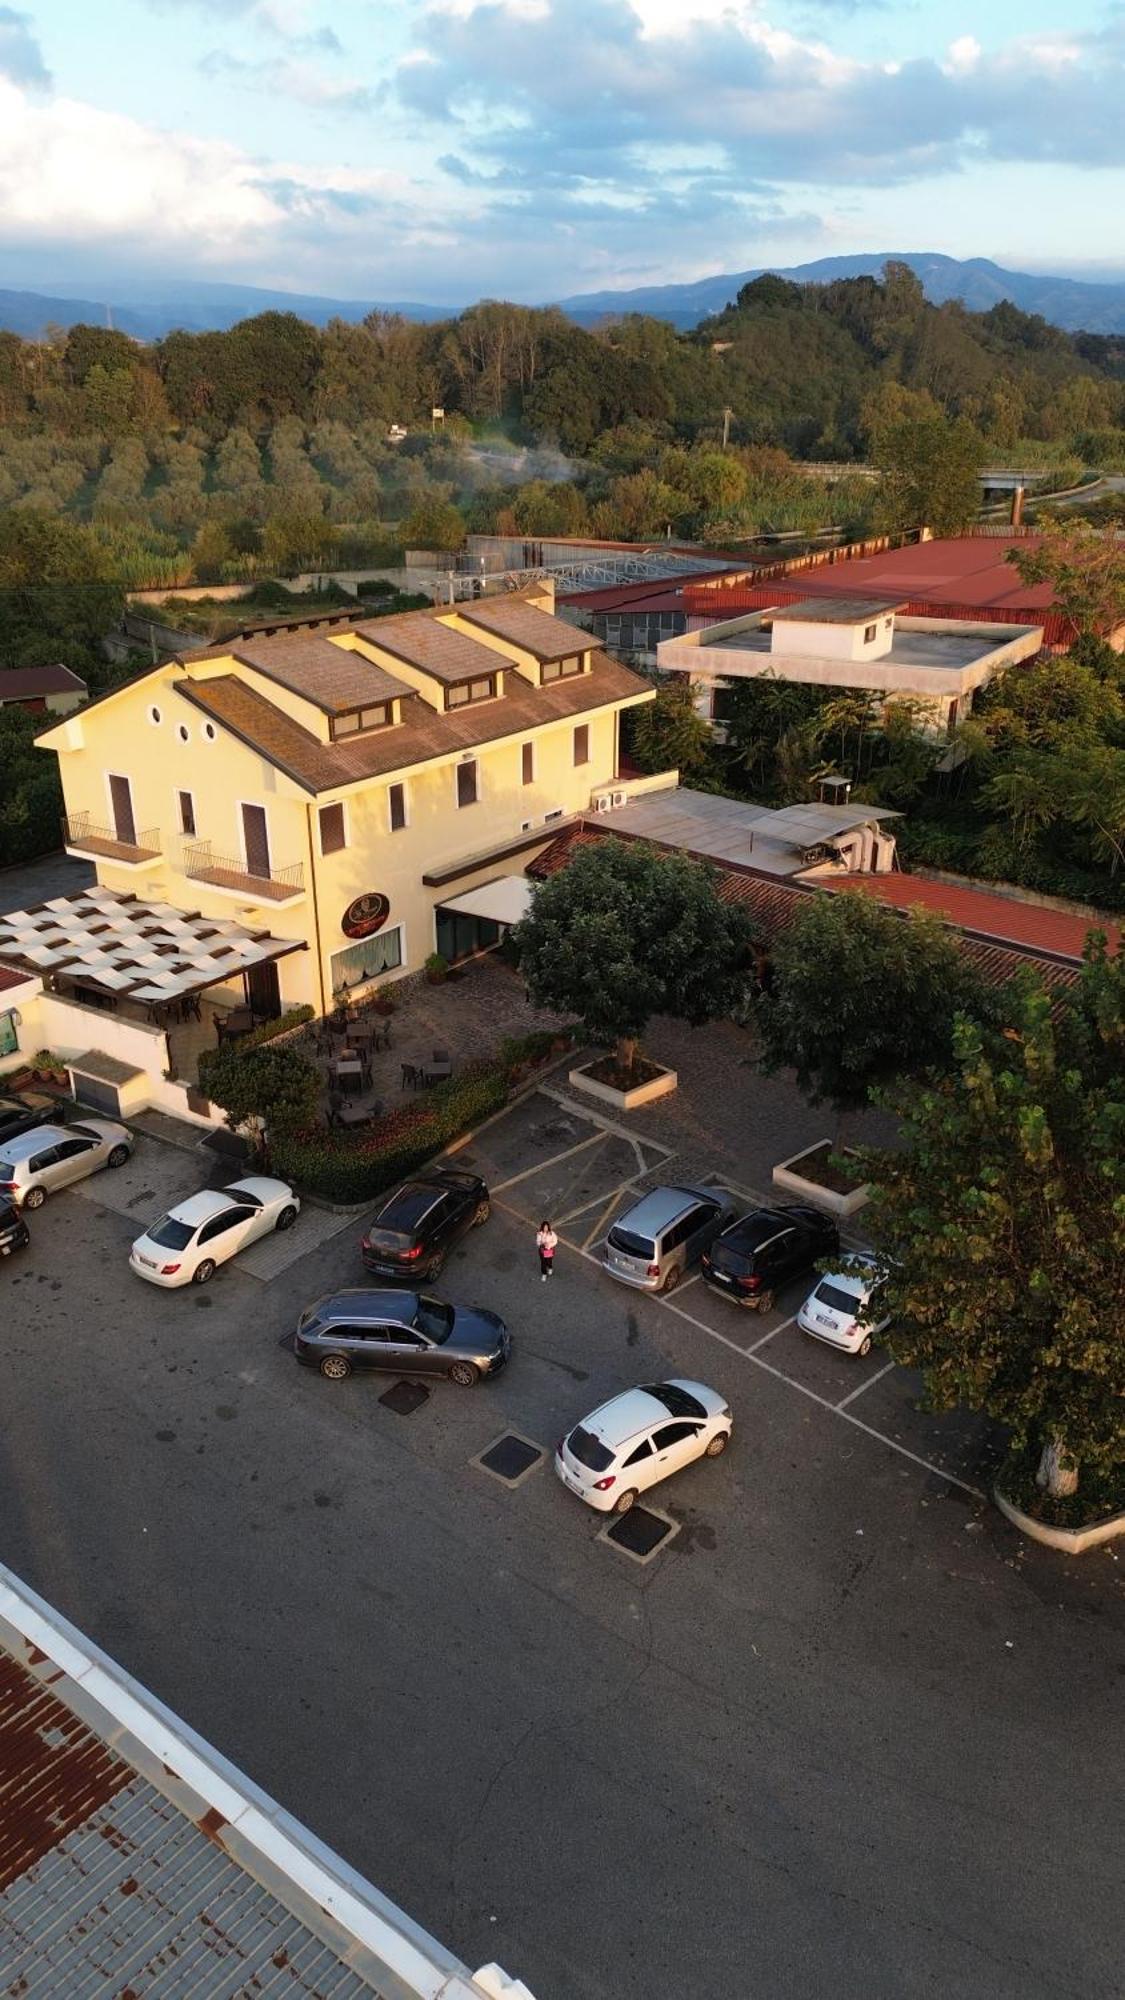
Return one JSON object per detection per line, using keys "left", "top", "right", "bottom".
{"left": 270, "top": 1030, "right": 558, "bottom": 1202}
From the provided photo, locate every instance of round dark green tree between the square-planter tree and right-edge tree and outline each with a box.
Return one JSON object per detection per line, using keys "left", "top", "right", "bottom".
{"left": 755, "top": 892, "right": 993, "bottom": 1136}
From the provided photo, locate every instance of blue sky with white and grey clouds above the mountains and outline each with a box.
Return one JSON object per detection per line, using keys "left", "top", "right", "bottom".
{"left": 0, "top": 0, "right": 1125, "bottom": 304}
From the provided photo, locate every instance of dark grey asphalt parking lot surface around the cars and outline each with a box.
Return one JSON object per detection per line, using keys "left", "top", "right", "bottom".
{"left": 0, "top": 1082, "right": 1125, "bottom": 2000}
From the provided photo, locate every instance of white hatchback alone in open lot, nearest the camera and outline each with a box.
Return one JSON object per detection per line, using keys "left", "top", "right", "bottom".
{"left": 554, "top": 1380, "right": 733, "bottom": 1514}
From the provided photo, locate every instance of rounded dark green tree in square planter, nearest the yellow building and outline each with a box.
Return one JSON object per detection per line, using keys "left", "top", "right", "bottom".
{"left": 512, "top": 838, "right": 751, "bottom": 1074}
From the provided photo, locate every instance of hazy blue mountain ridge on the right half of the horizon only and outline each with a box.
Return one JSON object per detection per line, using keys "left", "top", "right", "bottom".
{"left": 558, "top": 250, "right": 1125, "bottom": 334}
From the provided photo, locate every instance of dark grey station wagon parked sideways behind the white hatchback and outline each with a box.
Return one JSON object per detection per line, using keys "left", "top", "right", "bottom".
{"left": 292, "top": 1290, "right": 512, "bottom": 1388}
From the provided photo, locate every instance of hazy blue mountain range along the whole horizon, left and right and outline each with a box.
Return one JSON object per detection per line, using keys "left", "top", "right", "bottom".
{"left": 0, "top": 250, "right": 1125, "bottom": 340}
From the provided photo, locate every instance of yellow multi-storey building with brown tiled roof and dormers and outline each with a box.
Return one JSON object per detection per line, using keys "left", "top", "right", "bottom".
{"left": 28, "top": 584, "right": 653, "bottom": 1080}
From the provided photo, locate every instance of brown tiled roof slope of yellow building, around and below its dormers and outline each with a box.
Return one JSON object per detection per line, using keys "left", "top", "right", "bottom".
{"left": 176, "top": 652, "right": 651, "bottom": 792}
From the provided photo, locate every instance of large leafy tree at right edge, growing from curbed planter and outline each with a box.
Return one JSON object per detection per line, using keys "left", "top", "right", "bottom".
{"left": 848, "top": 934, "right": 1125, "bottom": 1494}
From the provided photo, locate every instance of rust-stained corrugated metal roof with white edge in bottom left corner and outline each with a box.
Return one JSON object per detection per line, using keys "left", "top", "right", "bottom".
{"left": 0, "top": 1568, "right": 530, "bottom": 2000}
